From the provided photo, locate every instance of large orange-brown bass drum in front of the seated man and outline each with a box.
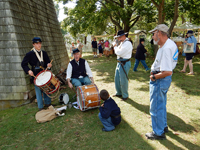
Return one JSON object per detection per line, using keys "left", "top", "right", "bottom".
{"left": 76, "top": 84, "right": 101, "bottom": 111}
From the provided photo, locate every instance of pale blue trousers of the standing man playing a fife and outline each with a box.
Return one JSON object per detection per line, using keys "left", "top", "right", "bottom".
{"left": 115, "top": 60, "right": 131, "bottom": 98}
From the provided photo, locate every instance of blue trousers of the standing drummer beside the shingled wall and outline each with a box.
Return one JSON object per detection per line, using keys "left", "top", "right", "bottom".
{"left": 35, "top": 85, "right": 51, "bottom": 109}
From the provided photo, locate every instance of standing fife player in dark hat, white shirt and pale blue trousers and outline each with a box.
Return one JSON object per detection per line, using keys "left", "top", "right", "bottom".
{"left": 113, "top": 30, "right": 133, "bottom": 100}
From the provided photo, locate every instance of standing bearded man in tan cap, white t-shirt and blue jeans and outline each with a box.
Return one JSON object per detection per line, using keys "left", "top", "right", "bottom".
{"left": 145, "top": 24, "right": 178, "bottom": 140}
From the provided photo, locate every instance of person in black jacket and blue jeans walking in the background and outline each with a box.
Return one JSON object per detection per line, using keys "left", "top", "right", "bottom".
{"left": 133, "top": 38, "right": 150, "bottom": 71}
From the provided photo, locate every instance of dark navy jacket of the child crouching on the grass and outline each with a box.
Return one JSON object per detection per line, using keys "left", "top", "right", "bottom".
{"left": 99, "top": 97, "right": 121, "bottom": 125}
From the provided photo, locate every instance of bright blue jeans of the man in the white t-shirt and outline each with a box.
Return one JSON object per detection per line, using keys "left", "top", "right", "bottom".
{"left": 149, "top": 76, "right": 172, "bottom": 136}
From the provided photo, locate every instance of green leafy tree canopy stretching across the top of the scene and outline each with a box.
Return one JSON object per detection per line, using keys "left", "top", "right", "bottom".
{"left": 56, "top": 0, "right": 200, "bottom": 36}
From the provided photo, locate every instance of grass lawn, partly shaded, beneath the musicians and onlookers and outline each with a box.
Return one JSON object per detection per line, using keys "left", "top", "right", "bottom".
{"left": 0, "top": 53, "right": 200, "bottom": 150}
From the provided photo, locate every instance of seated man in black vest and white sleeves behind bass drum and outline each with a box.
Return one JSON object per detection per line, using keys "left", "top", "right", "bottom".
{"left": 66, "top": 48, "right": 94, "bottom": 88}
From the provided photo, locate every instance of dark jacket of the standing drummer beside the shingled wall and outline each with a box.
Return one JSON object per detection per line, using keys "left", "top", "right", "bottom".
{"left": 21, "top": 51, "right": 50, "bottom": 76}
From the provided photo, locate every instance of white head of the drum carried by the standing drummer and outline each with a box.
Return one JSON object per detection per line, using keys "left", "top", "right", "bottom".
{"left": 35, "top": 71, "right": 52, "bottom": 86}
